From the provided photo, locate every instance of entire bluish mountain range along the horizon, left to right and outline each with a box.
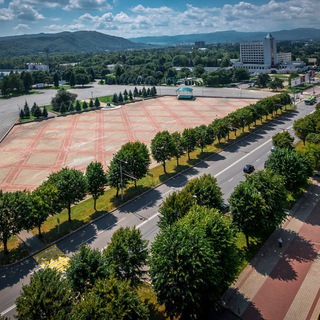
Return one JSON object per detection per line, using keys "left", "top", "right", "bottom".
{"left": 0, "top": 28, "right": 320, "bottom": 57}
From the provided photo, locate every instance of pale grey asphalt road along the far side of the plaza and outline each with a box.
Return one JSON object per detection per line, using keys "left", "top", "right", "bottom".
{"left": 0, "top": 82, "right": 274, "bottom": 142}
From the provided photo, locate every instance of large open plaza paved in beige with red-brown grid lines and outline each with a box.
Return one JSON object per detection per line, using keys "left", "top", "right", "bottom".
{"left": 0, "top": 96, "right": 256, "bottom": 191}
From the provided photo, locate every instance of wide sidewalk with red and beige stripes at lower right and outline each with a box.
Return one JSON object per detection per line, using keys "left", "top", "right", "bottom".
{"left": 222, "top": 179, "right": 320, "bottom": 320}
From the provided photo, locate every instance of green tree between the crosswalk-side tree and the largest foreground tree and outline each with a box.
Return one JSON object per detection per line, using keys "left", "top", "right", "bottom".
{"left": 103, "top": 227, "right": 148, "bottom": 285}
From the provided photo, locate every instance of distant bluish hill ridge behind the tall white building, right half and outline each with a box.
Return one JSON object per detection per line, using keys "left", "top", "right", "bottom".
{"left": 129, "top": 28, "right": 320, "bottom": 46}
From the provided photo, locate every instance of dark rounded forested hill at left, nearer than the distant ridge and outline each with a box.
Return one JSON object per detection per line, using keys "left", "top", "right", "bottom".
{"left": 0, "top": 31, "right": 142, "bottom": 57}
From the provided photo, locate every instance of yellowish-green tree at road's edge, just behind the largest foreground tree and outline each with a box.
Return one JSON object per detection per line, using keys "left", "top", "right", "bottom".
{"left": 158, "top": 190, "right": 196, "bottom": 229}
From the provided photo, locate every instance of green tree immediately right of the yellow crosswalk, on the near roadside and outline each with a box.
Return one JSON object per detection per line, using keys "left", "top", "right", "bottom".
{"left": 66, "top": 245, "right": 110, "bottom": 294}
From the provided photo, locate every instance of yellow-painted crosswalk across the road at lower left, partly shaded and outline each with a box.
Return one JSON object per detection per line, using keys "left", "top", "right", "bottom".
{"left": 33, "top": 244, "right": 70, "bottom": 272}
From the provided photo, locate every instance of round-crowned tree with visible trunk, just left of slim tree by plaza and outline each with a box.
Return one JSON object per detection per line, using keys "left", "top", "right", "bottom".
{"left": 48, "top": 168, "right": 88, "bottom": 221}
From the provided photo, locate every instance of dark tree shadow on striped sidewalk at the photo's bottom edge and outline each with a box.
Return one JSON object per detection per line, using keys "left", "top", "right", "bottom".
{"left": 220, "top": 287, "right": 264, "bottom": 320}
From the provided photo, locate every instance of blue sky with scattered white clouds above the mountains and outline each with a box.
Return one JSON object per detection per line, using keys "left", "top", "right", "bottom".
{"left": 0, "top": 0, "right": 320, "bottom": 39}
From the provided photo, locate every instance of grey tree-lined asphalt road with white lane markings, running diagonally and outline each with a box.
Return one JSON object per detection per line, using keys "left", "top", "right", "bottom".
{"left": 0, "top": 97, "right": 314, "bottom": 317}
